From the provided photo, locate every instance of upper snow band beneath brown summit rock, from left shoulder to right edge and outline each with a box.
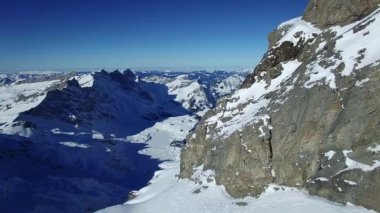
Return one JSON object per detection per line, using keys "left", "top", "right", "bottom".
{"left": 274, "top": 9, "right": 380, "bottom": 89}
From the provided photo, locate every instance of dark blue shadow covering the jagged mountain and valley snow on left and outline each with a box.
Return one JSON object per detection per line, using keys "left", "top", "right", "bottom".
{"left": 0, "top": 72, "right": 191, "bottom": 212}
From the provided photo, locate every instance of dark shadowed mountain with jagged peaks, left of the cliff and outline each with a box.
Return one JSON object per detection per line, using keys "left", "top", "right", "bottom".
{"left": 12, "top": 71, "right": 191, "bottom": 135}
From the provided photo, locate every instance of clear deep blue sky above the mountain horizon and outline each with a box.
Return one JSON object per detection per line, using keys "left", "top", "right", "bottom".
{"left": 0, "top": 0, "right": 308, "bottom": 71}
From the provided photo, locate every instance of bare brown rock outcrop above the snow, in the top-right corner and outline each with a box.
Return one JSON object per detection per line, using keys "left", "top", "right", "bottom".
{"left": 303, "top": 0, "right": 380, "bottom": 28}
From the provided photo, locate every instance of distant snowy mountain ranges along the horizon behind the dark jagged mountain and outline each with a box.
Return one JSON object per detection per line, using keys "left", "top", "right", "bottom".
{"left": 0, "top": 70, "right": 245, "bottom": 133}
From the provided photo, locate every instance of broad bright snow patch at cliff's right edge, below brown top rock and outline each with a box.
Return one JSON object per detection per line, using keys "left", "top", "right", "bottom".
{"left": 304, "top": 9, "right": 380, "bottom": 89}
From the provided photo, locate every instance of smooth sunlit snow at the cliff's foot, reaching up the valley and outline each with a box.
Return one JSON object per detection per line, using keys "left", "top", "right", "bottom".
{"left": 99, "top": 116, "right": 374, "bottom": 213}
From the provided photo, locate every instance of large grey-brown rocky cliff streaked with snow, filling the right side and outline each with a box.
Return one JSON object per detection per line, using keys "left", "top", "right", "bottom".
{"left": 181, "top": 0, "right": 380, "bottom": 211}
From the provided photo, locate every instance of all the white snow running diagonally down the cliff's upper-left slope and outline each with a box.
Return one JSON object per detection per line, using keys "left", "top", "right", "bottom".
{"left": 206, "top": 9, "right": 380, "bottom": 137}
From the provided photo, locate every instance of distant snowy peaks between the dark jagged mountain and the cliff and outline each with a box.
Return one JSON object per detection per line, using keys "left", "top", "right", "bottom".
{"left": 137, "top": 71, "right": 247, "bottom": 116}
